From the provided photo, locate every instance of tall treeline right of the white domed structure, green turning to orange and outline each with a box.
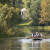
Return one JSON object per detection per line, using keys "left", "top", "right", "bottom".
{"left": 23, "top": 0, "right": 50, "bottom": 26}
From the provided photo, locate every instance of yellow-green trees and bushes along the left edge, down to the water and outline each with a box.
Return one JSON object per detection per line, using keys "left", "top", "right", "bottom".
{"left": 0, "top": 4, "right": 21, "bottom": 35}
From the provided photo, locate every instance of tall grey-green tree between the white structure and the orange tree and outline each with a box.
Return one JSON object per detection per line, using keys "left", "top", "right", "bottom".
{"left": 30, "top": 0, "right": 41, "bottom": 26}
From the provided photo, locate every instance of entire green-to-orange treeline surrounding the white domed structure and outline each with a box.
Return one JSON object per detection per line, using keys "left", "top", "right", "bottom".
{"left": 0, "top": 0, "right": 50, "bottom": 35}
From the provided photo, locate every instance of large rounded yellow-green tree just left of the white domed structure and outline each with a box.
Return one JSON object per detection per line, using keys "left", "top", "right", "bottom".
{"left": 1, "top": 4, "right": 21, "bottom": 27}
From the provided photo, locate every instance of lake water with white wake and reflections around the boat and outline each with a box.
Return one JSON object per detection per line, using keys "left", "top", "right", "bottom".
{"left": 0, "top": 29, "right": 50, "bottom": 50}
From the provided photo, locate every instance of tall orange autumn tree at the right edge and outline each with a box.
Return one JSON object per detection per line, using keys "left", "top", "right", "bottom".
{"left": 39, "top": 0, "right": 50, "bottom": 25}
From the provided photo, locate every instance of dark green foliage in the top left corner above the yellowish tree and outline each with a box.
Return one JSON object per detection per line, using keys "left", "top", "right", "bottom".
{"left": 0, "top": 0, "right": 23, "bottom": 8}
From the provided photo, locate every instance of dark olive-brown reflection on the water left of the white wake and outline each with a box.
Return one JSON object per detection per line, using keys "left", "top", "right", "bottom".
{"left": 0, "top": 38, "right": 21, "bottom": 50}
